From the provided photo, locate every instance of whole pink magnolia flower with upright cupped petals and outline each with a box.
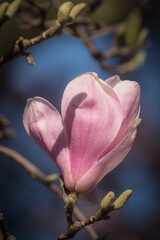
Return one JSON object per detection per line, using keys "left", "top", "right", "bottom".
{"left": 23, "top": 73, "right": 140, "bottom": 194}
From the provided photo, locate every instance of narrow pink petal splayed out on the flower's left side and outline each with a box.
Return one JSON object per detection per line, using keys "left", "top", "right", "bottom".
{"left": 23, "top": 97, "right": 73, "bottom": 190}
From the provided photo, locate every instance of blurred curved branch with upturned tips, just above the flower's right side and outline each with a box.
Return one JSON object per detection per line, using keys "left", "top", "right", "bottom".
{"left": 75, "top": 25, "right": 147, "bottom": 73}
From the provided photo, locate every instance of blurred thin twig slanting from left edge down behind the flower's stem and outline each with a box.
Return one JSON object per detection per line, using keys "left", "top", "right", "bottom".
{"left": 0, "top": 145, "right": 98, "bottom": 239}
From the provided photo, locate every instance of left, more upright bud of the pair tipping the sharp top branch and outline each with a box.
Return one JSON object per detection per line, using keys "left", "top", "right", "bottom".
{"left": 57, "top": 1, "right": 73, "bottom": 23}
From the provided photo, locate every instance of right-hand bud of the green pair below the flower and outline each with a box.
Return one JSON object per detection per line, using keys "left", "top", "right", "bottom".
{"left": 112, "top": 190, "right": 133, "bottom": 210}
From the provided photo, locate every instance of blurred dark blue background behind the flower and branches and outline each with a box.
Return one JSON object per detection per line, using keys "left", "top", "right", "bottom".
{"left": 0, "top": 0, "right": 160, "bottom": 240}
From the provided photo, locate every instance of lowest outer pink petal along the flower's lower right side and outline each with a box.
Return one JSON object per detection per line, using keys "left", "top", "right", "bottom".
{"left": 75, "top": 119, "right": 137, "bottom": 194}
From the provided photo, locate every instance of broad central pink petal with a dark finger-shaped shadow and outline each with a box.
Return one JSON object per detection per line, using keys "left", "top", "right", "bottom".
{"left": 62, "top": 73, "right": 122, "bottom": 184}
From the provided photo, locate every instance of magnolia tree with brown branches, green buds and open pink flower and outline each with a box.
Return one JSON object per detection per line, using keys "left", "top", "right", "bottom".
{"left": 0, "top": 0, "right": 147, "bottom": 240}
